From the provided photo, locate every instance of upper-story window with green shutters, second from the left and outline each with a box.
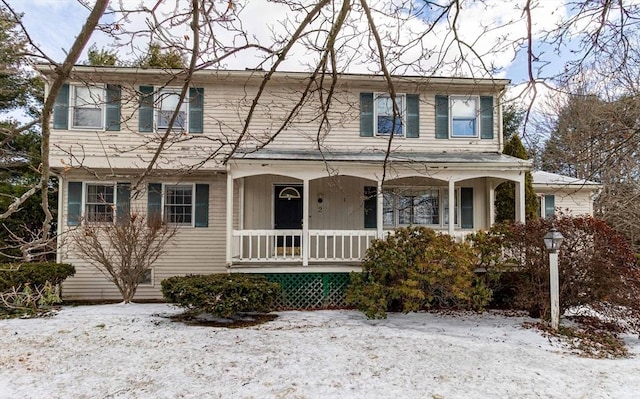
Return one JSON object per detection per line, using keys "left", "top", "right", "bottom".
{"left": 138, "top": 86, "right": 204, "bottom": 133}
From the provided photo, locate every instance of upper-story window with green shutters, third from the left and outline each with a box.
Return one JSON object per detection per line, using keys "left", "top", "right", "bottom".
{"left": 360, "top": 93, "right": 420, "bottom": 138}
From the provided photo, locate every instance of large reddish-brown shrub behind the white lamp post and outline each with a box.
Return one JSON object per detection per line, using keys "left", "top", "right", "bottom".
{"left": 471, "top": 214, "right": 640, "bottom": 332}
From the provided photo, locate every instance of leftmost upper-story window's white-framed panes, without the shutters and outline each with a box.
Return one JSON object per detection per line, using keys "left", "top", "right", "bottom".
{"left": 71, "top": 86, "right": 105, "bottom": 129}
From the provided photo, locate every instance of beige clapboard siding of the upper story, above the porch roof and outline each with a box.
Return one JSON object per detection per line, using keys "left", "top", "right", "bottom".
{"left": 50, "top": 76, "right": 500, "bottom": 169}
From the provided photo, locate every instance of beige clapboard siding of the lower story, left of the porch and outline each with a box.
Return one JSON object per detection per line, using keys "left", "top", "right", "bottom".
{"left": 59, "top": 175, "right": 226, "bottom": 300}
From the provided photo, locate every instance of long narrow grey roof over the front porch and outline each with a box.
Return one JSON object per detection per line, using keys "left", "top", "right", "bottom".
{"left": 233, "top": 148, "right": 532, "bottom": 169}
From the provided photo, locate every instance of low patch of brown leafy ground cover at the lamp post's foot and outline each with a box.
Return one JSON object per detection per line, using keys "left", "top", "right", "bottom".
{"left": 525, "top": 316, "right": 630, "bottom": 359}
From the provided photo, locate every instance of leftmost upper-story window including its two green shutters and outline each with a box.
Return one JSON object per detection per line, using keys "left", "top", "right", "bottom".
{"left": 53, "top": 83, "right": 121, "bottom": 131}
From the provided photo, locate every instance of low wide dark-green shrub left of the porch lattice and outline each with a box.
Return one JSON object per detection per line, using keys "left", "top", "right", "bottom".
{"left": 161, "top": 274, "right": 280, "bottom": 317}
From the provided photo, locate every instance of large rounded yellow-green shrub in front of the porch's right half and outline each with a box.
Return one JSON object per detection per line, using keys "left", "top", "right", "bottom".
{"left": 347, "top": 227, "right": 491, "bottom": 318}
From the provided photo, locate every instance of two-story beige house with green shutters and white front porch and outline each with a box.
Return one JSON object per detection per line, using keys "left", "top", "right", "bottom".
{"left": 38, "top": 66, "right": 531, "bottom": 299}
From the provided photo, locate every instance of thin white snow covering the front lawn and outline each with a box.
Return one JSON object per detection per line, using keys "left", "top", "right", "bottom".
{"left": 0, "top": 304, "right": 640, "bottom": 399}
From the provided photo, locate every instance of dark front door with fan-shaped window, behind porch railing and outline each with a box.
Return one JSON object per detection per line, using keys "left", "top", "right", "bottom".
{"left": 273, "top": 184, "right": 304, "bottom": 247}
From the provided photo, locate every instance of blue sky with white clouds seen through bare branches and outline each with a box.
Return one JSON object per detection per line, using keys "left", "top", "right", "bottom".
{"left": 5, "top": 0, "right": 604, "bottom": 126}
